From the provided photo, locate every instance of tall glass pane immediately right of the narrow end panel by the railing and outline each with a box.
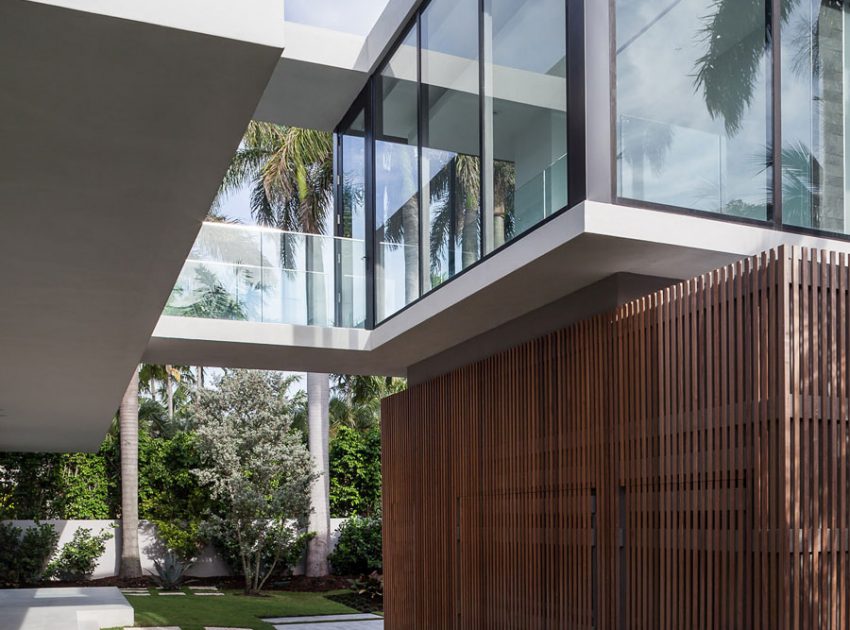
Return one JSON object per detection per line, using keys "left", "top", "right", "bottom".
{"left": 375, "top": 25, "right": 419, "bottom": 321}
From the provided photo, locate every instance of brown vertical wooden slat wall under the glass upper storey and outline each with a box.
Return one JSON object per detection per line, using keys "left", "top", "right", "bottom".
{"left": 383, "top": 249, "right": 850, "bottom": 630}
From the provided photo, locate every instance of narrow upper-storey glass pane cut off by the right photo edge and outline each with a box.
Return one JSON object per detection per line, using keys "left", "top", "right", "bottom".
{"left": 782, "top": 0, "right": 850, "bottom": 234}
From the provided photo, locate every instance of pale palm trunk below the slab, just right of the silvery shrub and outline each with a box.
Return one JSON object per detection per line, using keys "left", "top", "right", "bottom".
{"left": 307, "top": 373, "right": 331, "bottom": 577}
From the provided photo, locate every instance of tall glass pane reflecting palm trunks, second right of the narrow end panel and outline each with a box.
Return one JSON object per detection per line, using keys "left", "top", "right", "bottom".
{"left": 421, "top": 0, "right": 481, "bottom": 288}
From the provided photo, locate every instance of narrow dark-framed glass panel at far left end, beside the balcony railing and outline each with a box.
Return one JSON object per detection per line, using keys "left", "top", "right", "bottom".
{"left": 336, "top": 108, "right": 366, "bottom": 328}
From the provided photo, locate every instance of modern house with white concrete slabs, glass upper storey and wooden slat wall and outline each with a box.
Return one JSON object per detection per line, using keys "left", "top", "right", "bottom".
{"left": 8, "top": 0, "right": 850, "bottom": 630}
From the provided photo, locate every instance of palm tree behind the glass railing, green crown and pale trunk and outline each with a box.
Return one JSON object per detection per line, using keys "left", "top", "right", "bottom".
{"left": 213, "top": 121, "right": 333, "bottom": 576}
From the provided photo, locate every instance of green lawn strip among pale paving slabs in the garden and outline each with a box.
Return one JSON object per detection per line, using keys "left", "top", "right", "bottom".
{"left": 112, "top": 589, "right": 357, "bottom": 630}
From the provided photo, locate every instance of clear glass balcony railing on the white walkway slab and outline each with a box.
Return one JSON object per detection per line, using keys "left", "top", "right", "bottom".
{"left": 164, "top": 223, "right": 366, "bottom": 328}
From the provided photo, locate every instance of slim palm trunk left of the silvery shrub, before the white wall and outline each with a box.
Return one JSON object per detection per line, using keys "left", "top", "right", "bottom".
{"left": 118, "top": 369, "right": 142, "bottom": 578}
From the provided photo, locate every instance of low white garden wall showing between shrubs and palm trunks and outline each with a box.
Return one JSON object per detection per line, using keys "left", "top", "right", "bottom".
{"left": 8, "top": 518, "right": 345, "bottom": 578}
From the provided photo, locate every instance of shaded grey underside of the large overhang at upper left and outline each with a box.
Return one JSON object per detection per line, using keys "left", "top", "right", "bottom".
{"left": 0, "top": 0, "right": 281, "bottom": 451}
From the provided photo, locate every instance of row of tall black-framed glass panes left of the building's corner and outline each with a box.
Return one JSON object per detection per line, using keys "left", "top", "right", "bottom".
{"left": 348, "top": 0, "right": 567, "bottom": 322}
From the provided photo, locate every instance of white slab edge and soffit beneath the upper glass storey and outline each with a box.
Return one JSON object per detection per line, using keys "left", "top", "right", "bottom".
{"left": 146, "top": 202, "right": 850, "bottom": 374}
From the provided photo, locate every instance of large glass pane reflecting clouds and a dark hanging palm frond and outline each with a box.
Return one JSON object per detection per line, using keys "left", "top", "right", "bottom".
{"left": 616, "top": 0, "right": 771, "bottom": 219}
